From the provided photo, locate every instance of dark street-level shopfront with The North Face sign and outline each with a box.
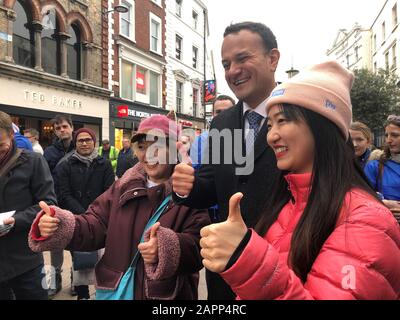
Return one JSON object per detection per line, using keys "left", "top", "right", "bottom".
{"left": 109, "top": 98, "right": 168, "bottom": 149}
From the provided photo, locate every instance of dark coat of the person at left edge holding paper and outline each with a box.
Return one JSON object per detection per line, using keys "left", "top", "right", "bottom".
{"left": 0, "top": 149, "right": 57, "bottom": 282}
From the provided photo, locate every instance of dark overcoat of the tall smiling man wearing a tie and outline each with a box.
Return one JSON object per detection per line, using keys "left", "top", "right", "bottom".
{"left": 174, "top": 102, "right": 279, "bottom": 300}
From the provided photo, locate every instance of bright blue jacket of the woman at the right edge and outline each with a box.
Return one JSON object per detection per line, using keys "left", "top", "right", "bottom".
{"left": 364, "top": 160, "right": 400, "bottom": 200}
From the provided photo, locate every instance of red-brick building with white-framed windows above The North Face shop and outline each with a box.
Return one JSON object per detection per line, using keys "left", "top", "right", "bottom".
{"left": 103, "top": 0, "right": 167, "bottom": 147}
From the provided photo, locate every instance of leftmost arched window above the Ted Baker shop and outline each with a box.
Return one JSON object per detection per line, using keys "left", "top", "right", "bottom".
{"left": 13, "top": 0, "right": 35, "bottom": 68}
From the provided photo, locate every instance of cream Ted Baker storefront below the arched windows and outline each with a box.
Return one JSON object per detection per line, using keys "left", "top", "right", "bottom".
{"left": 0, "top": 67, "right": 109, "bottom": 148}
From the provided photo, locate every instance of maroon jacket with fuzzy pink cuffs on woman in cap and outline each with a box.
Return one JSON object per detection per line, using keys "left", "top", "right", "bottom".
{"left": 29, "top": 165, "right": 210, "bottom": 300}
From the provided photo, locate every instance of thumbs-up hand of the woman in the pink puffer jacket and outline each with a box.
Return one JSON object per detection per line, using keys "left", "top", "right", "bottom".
{"left": 200, "top": 193, "right": 247, "bottom": 273}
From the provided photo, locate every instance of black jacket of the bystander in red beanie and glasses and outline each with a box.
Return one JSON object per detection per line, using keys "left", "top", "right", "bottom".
{"left": 55, "top": 156, "right": 115, "bottom": 214}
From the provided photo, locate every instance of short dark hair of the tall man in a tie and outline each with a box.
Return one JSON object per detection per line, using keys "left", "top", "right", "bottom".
{"left": 224, "top": 21, "right": 278, "bottom": 51}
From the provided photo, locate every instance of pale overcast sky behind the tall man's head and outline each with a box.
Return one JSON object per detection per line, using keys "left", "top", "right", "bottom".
{"left": 203, "top": 0, "right": 385, "bottom": 94}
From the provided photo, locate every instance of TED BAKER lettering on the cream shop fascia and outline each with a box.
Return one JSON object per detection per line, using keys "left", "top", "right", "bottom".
{"left": 24, "top": 90, "right": 83, "bottom": 110}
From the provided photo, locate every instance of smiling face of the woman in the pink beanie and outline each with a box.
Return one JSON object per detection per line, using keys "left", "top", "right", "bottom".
{"left": 267, "top": 105, "right": 315, "bottom": 173}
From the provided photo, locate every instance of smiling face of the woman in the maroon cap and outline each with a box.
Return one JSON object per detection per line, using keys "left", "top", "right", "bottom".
{"left": 134, "top": 141, "right": 174, "bottom": 183}
